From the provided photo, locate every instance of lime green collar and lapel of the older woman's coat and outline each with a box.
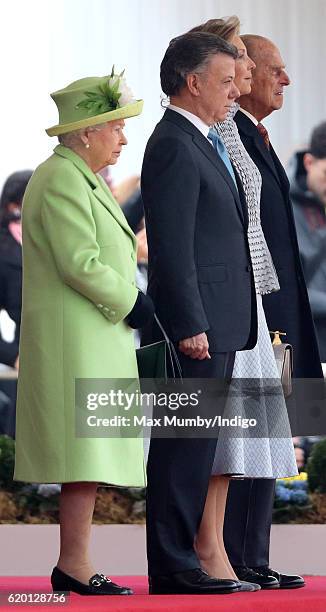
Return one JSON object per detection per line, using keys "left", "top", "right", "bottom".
{"left": 54, "top": 144, "right": 137, "bottom": 247}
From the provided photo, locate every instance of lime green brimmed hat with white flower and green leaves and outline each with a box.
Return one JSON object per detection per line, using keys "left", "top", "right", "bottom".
{"left": 46, "top": 66, "right": 144, "bottom": 136}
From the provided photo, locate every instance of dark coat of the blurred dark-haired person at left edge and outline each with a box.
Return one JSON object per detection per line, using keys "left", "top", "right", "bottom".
{"left": 0, "top": 229, "right": 22, "bottom": 366}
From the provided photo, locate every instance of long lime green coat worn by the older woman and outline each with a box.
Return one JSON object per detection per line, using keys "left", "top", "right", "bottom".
{"left": 14, "top": 145, "right": 145, "bottom": 486}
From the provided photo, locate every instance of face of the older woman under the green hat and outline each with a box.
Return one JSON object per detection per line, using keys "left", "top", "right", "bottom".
{"left": 88, "top": 119, "right": 128, "bottom": 172}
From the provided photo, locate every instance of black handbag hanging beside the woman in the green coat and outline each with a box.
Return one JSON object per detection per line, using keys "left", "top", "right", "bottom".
{"left": 136, "top": 314, "right": 182, "bottom": 380}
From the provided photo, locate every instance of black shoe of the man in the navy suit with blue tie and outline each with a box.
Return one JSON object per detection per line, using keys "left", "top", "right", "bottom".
{"left": 148, "top": 568, "right": 239, "bottom": 595}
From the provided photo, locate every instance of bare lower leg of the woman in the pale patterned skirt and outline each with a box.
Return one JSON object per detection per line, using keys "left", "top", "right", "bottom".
{"left": 195, "top": 476, "right": 237, "bottom": 579}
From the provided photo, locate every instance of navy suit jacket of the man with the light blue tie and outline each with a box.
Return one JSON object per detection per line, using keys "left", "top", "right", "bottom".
{"left": 142, "top": 109, "right": 257, "bottom": 352}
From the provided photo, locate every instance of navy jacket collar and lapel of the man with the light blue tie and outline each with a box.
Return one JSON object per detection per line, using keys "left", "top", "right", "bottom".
{"left": 162, "top": 109, "right": 244, "bottom": 222}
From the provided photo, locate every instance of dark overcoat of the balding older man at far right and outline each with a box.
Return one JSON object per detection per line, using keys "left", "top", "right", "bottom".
{"left": 235, "top": 111, "right": 322, "bottom": 378}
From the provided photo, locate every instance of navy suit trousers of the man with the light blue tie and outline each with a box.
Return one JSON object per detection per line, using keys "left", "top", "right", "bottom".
{"left": 147, "top": 352, "right": 235, "bottom": 576}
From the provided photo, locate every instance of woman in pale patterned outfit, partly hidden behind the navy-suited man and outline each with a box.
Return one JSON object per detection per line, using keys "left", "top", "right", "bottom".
{"left": 192, "top": 15, "right": 297, "bottom": 590}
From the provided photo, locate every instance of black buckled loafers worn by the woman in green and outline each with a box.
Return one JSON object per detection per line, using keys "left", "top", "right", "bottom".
{"left": 51, "top": 567, "right": 133, "bottom": 595}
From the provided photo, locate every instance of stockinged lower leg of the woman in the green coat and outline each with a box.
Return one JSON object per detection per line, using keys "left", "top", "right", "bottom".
{"left": 57, "top": 482, "right": 98, "bottom": 584}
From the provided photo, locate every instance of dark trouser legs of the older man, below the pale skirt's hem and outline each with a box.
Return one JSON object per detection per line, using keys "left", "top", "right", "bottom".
{"left": 224, "top": 478, "right": 275, "bottom": 567}
